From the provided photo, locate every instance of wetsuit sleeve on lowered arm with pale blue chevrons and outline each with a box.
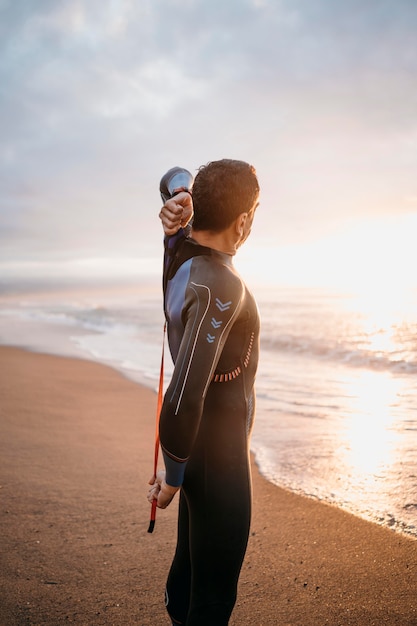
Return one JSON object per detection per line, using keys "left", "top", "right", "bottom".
{"left": 160, "top": 257, "right": 243, "bottom": 486}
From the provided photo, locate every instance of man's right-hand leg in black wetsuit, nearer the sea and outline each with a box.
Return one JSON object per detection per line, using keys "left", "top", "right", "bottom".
{"left": 185, "top": 432, "right": 251, "bottom": 626}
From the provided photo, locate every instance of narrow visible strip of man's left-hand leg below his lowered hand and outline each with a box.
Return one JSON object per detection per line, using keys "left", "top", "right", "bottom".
{"left": 165, "top": 492, "right": 191, "bottom": 626}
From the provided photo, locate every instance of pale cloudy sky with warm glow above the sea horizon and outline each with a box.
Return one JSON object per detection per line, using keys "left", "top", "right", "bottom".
{"left": 0, "top": 0, "right": 417, "bottom": 288}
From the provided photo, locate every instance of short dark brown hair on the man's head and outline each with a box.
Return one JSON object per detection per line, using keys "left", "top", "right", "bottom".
{"left": 193, "top": 159, "right": 259, "bottom": 232}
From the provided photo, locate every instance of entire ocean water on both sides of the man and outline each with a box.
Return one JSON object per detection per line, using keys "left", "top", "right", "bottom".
{"left": 0, "top": 281, "right": 417, "bottom": 537}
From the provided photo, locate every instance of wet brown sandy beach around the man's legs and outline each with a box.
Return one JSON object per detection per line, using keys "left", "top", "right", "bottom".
{"left": 0, "top": 347, "right": 417, "bottom": 626}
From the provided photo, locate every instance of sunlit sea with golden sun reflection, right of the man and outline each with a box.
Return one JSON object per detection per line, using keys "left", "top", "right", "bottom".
{"left": 257, "top": 278, "right": 417, "bottom": 535}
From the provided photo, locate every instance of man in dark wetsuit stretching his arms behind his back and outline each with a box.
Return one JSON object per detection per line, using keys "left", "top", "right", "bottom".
{"left": 148, "top": 159, "right": 259, "bottom": 626}
